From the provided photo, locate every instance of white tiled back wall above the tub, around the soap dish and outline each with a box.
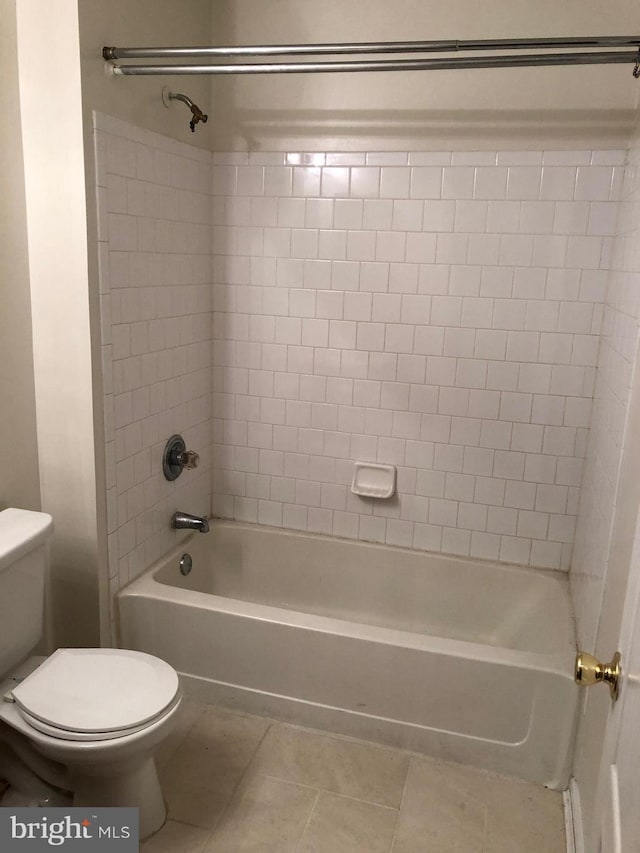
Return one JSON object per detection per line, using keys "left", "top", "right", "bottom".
{"left": 211, "top": 151, "right": 625, "bottom": 570}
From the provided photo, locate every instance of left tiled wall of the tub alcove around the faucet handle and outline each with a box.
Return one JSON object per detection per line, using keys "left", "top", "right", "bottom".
{"left": 94, "top": 113, "right": 212, "bottom": 621}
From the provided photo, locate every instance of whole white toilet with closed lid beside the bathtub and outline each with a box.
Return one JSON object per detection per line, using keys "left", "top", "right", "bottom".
{"left": 0, "top": 509, "right": 182, "bottom": 838}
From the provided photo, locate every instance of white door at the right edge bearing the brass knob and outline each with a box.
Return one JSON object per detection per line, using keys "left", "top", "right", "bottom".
{"left": 596, "top": 506, "right": 640, "bottom": 853}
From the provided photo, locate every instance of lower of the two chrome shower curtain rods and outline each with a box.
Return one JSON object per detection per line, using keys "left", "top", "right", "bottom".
{"left": 106, "top": 50, "right": 639, "bottom": 77}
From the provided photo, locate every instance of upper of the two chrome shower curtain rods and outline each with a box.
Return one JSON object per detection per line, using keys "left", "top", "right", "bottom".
{"left": 102, "top": 36, "right": 640, "bottom": 60}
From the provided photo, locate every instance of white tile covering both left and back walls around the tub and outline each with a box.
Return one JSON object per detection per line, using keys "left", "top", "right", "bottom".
{"left": 96, "top": 108, "right": 625, "bottom": 592}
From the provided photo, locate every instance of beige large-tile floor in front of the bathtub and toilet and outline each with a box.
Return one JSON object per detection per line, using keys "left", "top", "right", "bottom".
{"left": 141, "top": 700, "right": 566, "bottom": 853}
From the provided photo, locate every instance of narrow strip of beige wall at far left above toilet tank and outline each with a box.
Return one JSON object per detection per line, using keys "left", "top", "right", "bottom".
{"left": 0, "top": 0, "right": 40, "bottom": 510}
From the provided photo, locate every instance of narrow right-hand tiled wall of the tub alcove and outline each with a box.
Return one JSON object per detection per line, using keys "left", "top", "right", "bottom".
{"left": 571, "top": 134, "right": 640, "bottom": 648}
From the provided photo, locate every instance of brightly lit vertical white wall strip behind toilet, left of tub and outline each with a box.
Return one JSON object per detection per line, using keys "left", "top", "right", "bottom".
{"left": 17, "top": 0, "right": 98, "bottom": 645}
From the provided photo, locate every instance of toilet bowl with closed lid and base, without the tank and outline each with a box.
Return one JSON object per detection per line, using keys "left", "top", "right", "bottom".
{"left": 0, "top": 649, "right": 182, "bottom": 838}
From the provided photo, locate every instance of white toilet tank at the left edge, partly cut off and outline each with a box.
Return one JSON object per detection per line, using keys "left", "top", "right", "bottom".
{"left": 0, "top": 509, "right": 53, "bottom": 678}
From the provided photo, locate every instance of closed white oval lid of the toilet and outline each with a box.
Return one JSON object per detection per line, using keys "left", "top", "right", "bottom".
{"left": 12, "top": 649, "right": 179, "bottom": 733}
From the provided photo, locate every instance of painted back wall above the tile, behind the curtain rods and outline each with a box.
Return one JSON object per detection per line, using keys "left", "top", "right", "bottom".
{"left": 212, "top": 0, "right": 640, "bottom": 151}
